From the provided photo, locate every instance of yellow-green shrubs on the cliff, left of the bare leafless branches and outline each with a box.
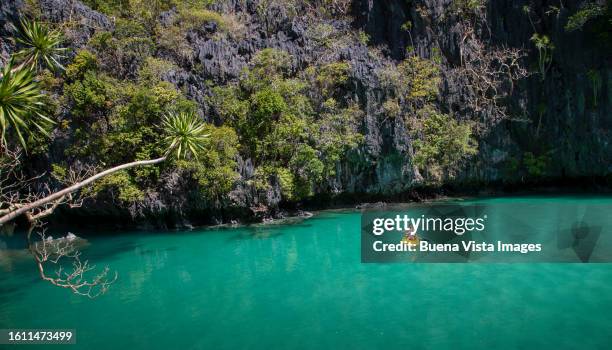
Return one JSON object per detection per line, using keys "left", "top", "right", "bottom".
{"left": 378, "top": 50, "right": 477, "bottom": 182}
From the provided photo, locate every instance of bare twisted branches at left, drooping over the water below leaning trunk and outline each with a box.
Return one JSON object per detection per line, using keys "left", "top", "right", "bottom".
{"left": 0, "top": 148, "right": 117, "bottom": 298}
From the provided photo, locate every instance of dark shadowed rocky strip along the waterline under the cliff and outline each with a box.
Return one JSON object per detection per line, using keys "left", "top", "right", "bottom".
{"left": 43, "top": 178, "right": 612, "bottom": 230}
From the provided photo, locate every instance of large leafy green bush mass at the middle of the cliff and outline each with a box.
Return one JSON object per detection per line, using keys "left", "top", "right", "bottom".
{"left": 210, "top": 49, "right": 362, "bottom": 200}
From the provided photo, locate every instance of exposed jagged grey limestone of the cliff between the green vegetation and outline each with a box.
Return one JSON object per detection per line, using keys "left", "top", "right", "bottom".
{"left": 0, "top": 0, "right": 612, "bottom": 225}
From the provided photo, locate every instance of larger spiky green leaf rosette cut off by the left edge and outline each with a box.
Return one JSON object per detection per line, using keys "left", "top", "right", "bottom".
{"left": 0, "top": 60, "right": 53, "bottom": 148}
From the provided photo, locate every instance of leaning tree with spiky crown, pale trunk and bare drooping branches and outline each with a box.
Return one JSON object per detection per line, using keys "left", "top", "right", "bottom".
{"left": 0, "top": 113, "right": 208, "bottom": 298}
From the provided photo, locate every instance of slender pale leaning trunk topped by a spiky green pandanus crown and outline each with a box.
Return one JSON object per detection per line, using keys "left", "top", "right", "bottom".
{"left": 0, "top": 113, "right": 209, "bottom": 226}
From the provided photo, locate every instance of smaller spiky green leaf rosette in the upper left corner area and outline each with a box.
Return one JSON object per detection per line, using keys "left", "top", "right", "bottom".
{"left": 15, "top": 19, "right": 66, "bottom": 70}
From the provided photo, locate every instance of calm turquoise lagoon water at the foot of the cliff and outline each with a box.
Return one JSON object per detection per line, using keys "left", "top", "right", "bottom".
{"left": 0, "top": 197, "right": 612, "bottom": 350}
